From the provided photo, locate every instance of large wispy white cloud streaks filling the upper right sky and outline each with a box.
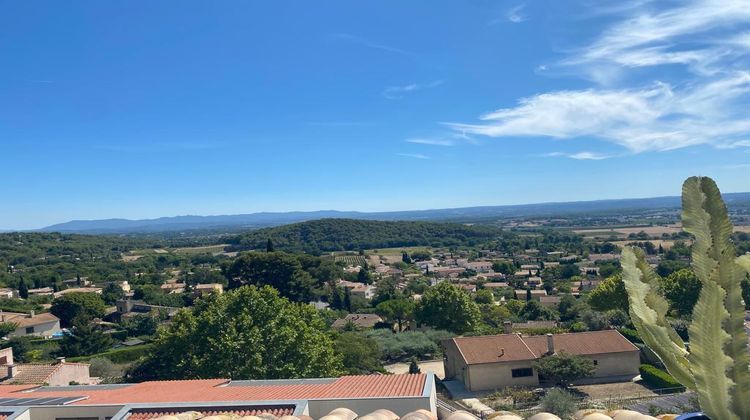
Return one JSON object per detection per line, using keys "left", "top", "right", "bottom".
{"left": 450, "top": 0, "right": 750, "bottom": 154}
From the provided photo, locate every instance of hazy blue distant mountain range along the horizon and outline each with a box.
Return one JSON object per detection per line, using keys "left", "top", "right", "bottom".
{"left": 32, "top": 193, "right": 750, "bottom": 234}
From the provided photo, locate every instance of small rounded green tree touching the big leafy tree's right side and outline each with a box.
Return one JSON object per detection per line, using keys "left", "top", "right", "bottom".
{"left": 334, "top": 332, "right": 385, "bottom": 375}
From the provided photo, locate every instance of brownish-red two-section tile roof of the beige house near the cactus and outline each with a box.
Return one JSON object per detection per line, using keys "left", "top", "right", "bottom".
{"left": 451, "top": 330, "right": 638, "bottom": 365}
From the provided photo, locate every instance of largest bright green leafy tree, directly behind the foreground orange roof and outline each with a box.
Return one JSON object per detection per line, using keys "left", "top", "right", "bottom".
{"left": 129, "top": 286, "right": 342, "bottom": 380}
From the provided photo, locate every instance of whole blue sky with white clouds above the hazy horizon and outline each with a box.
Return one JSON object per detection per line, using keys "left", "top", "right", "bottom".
{"left": 0, "top": 0, "right": 750, "bottom": 228}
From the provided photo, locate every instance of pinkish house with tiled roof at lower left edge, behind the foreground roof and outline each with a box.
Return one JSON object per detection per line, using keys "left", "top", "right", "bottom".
{"left": 0, "top": 352, "right": 95, "bottom": 386}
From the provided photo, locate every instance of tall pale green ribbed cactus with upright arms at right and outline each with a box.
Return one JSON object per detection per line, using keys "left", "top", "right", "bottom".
{"left": 622, "top": 177, "right": 750, "bottom": 420}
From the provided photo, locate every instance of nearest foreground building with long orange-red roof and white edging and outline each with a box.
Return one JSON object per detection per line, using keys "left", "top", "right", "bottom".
{"left": 0, "top": 373, "right": 438, "bottom": 420}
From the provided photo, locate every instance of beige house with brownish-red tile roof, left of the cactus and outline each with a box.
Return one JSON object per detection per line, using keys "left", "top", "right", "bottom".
{"left": 442, "top": 330, "right": 640, "bottom": 391}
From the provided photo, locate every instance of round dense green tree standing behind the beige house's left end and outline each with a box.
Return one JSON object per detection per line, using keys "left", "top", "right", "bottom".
{"left": 416, "top": 282, "right": 482, "bottom": 334}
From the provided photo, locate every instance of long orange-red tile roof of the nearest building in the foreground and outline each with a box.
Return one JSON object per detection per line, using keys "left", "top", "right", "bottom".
{"left": 0, "top": 374, "right": 427, "bottom": 405}
